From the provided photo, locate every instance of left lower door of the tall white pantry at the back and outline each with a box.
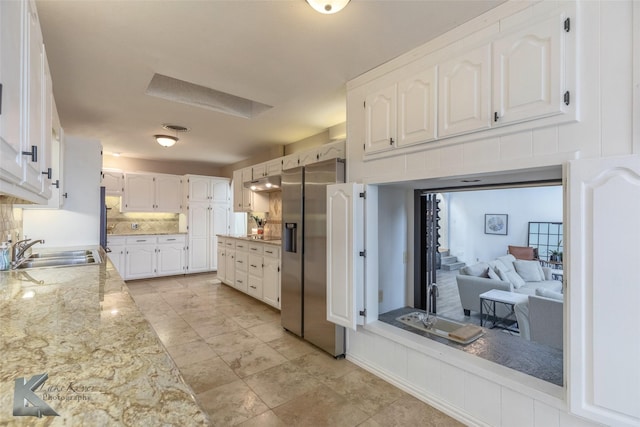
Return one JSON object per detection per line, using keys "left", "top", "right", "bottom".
{"left": 188, "top": 203, "right": 211, "bottom": 273}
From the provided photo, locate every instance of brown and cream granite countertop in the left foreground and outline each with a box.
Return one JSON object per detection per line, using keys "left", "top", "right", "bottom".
{"left": 0, "top": 252, "right": 209, "bottom": 426}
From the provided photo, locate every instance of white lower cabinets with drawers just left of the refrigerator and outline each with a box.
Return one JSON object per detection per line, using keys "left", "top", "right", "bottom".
{"left": 218, "top": 236, "right": 280, "bottom": 309}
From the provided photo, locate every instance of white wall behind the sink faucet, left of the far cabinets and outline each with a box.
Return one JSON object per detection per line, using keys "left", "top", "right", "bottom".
{"left": 22, "top": 135, "right": 102, "bottom": 247}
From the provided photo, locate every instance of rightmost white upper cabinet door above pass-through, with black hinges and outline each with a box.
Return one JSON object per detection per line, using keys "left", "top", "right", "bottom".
{"left": 493, "top": 16, "right": 567, "bottom": 125}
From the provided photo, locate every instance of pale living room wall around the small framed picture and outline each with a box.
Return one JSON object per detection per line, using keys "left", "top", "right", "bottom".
{"left": 448, "top": 186, "right": 563, "bottom": 264}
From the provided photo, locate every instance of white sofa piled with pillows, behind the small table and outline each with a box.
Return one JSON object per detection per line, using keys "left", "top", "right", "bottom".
{"left": 456, "top": 255, "right": 562, "bottom": 316}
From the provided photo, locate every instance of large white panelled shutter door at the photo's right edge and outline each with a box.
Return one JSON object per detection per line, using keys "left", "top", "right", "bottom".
{"left": 564, "top": 156, "right": 640, "bottom": 426}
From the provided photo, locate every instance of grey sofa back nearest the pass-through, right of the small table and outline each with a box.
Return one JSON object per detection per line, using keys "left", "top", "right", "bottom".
{"left": 514, "top": 288, "right": 564, "bottom": 349}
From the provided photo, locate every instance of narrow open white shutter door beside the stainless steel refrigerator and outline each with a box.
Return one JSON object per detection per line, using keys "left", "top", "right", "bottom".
{"left": 327, "top": 183, "right": 365, "bottom": 330}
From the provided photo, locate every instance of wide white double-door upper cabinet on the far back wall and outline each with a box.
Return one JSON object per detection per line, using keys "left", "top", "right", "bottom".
{"left": 121, "top": 173, "right": 182, "bottom": 213}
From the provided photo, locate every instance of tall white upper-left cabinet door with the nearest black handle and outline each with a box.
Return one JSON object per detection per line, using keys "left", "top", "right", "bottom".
{"left": 22, "top": 2, "right": 44, "bottom": 193}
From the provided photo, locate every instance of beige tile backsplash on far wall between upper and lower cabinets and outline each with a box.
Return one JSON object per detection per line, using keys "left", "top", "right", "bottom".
{"left": 105, "top": 196, "right": 180, "bottom": 234}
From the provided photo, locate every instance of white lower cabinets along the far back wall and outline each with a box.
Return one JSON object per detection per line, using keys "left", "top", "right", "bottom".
{"left": 107, "top": 234, "right": 186, "bottom": 280}
